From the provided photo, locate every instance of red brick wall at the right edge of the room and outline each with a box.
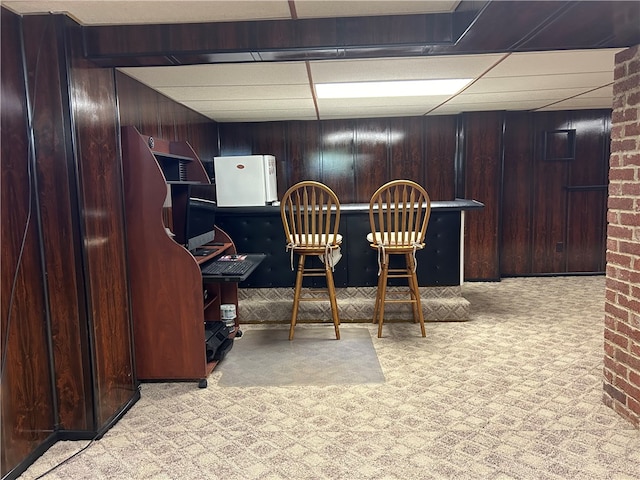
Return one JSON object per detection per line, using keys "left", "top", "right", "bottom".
{"left": 603, "top": 45, "right": 640, "bottom": 427}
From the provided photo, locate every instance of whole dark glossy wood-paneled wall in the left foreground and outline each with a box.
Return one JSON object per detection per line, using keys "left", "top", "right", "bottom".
{"left": 1, "top": 9, "right": 139, "bottom": 478}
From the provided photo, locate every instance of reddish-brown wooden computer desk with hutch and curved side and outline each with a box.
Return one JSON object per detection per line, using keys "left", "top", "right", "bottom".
{"left": 122, "top": 126, "right": 238, "bottom": 387}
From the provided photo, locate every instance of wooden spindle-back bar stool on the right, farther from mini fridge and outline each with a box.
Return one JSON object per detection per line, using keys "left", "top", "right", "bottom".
{"left": 367, "top": 180, "right": 431, "bottom": 338}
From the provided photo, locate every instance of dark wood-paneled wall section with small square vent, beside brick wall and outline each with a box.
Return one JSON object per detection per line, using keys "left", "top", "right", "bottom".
{"left": 500, "top": 110, "right": 611, "bottom": 276}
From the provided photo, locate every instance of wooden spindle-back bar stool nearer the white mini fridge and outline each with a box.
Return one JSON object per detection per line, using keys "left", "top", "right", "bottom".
{"left": 280, "top": 181, "right": 342, "bottom": 340}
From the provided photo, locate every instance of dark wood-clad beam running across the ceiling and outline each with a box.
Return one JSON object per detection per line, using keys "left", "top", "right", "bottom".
{"left": 85, "top": 0, "right": 640, "bottom": 66}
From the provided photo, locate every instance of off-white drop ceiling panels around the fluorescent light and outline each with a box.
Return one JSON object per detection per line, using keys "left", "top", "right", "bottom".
{"left": 2, "top": 0, "right": 636, "bottom": 122}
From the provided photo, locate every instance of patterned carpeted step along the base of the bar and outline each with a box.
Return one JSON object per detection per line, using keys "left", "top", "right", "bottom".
{"left": 238, "top": 286, "right": 470, "bottom": 323}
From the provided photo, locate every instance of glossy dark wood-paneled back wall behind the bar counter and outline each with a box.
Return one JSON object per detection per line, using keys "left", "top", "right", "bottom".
{"left": 219, "top": 116, "right": 457, "bottom": 203}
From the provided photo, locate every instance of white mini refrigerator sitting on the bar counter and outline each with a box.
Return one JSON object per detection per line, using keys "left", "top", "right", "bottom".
{"left": 213, "top": 155, "right": 278, "bottom": 207}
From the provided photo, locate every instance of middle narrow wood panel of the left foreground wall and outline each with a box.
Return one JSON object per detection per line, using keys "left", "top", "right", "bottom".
{"left": 24, "top": 16, "right": 93, "bottom": 430}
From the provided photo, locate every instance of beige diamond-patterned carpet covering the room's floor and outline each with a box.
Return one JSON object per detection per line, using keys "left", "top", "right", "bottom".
{"left": 15, "top": 277, "right": 640, "bottom": 480}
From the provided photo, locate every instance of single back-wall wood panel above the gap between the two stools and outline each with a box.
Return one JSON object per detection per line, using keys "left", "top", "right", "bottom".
{"left": 356, "top": 119, "right": 392, "bottom": 202}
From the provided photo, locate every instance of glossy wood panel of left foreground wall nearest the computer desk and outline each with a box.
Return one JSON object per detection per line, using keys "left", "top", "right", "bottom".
{"left": 67, "top": 19, "right": 137, "bottom": 428}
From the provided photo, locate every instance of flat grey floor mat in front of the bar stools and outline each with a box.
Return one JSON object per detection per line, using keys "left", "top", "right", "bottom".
{"left": 218, "top": 325, "right": 384, "bottom": 387}
